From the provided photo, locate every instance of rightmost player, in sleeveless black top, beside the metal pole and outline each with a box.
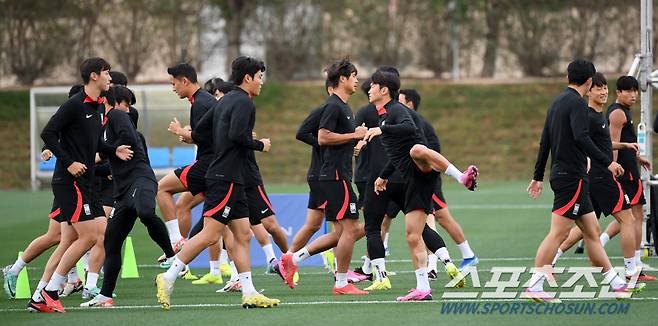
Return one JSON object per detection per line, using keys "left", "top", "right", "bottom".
{"left": 600, "top": 76, "right": 656, "bottom": 281}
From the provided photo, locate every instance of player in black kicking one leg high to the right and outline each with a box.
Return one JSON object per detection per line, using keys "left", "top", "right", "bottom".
{"left": 364, "top": 70, "right": 477, "bottom": 301}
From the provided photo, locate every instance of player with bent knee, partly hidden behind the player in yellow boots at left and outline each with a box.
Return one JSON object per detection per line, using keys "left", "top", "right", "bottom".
{"left": 157, "top": 63, "right": 217, "bottom": 264}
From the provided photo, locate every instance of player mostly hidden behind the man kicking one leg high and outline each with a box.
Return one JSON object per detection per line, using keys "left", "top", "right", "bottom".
{"left": 399, "top": 89, "right": 478, "bottom": 279}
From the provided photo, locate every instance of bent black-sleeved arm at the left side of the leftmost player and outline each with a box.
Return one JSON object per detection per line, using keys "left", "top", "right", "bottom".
{"left": 41, "top": 102, "right": 76, "bottom": 168}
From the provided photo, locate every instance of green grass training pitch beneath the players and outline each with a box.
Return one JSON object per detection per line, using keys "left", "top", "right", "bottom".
{"left": 0, "top": 182, "right": 658, "bottom": 326}
